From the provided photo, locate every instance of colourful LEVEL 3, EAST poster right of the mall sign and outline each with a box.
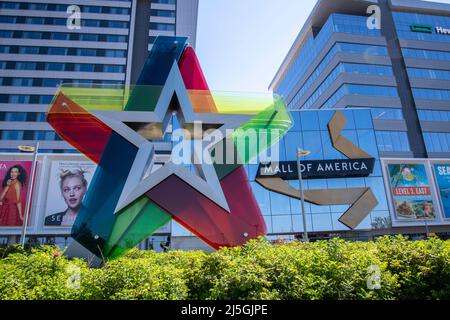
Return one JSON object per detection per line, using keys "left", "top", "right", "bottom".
{"left": 388, "top": 164, "right": 436, "bottom": 220}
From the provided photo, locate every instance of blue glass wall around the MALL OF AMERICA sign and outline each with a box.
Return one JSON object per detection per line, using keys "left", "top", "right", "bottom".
{"left": 247, "top": 109, "right": 389, "bottom": 234}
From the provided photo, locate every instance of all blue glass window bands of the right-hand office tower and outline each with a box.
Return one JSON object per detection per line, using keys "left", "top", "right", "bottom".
{"left": 275, "top": 7, "right": 450, "bottom": 158}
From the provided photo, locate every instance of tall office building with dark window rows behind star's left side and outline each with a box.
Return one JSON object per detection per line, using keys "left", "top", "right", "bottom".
{"left": 0, "top": 0, "right": 198, "bottom": 153}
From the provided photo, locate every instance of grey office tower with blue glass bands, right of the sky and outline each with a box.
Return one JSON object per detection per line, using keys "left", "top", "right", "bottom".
{"left": 270, "top": 0, "right": 450, "bottom": 158}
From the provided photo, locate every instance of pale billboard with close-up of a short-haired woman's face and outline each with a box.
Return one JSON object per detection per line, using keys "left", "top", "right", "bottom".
{"left": 44, "top": 160, "right": 96, "bottom": 227}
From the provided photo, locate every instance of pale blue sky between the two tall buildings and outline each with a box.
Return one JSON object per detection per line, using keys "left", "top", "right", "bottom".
{"left": 196, "top": 0, "right": 450, "bottom": 92}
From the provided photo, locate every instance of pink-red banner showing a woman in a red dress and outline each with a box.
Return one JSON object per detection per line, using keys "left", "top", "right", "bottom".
{"left": 0, "top": 160, "right": 33, "bottom": 227}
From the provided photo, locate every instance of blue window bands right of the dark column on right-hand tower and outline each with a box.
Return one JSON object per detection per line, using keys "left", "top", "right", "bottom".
{"left": 394, "top": 12, "right": 450, "bottom": 157}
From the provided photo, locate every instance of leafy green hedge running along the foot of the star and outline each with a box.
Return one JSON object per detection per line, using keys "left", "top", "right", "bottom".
{"left": 0, "top": 237, "right": 450, "bottom": 299}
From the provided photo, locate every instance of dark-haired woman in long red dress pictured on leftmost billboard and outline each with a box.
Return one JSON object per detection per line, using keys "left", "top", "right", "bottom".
{"left": 0, "top": 164, "right": 27, "bottom": 227}
